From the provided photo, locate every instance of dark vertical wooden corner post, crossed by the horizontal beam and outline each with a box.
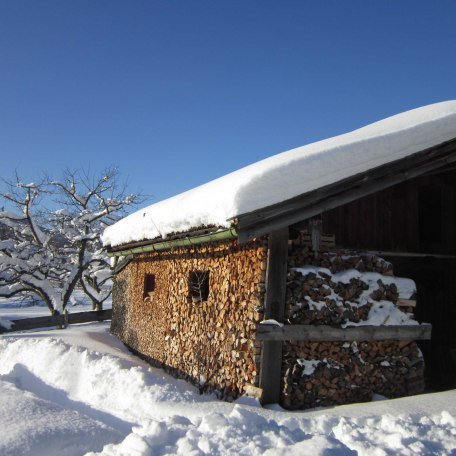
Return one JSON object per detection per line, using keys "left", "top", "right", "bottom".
{"left": 260, "top": 227, "right": 288, "bottom": 404}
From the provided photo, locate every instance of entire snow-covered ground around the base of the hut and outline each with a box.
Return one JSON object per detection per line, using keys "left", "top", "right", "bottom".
{"left": 0, "top": 323, "right": 456, "bottom": 456}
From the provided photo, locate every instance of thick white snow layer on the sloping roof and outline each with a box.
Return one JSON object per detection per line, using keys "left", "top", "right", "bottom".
{"left": 103, "top": 101, "right": 456, "bottom": 246}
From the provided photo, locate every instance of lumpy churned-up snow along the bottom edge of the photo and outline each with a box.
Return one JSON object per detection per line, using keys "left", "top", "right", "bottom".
{"left": 91, "top": 405, "right": 456, "bottom": 456}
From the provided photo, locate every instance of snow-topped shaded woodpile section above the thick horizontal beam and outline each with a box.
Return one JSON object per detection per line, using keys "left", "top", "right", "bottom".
{"left": 286, "top": 246, "right": 418, "bottom": 327}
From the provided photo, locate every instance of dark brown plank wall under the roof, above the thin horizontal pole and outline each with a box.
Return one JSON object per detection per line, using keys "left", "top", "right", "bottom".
{"left": 323, "top": 171, "right": 456, "bottom": 255}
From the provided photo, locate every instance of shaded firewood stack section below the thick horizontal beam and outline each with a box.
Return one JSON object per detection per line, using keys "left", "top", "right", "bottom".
{"left": 282, "top": 341, "right": 424, "bottom": 409}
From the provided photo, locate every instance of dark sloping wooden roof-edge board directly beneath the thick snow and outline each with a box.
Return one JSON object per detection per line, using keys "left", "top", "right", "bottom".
{"left": 237, "top": 140, "right": 456, "bottom": 242}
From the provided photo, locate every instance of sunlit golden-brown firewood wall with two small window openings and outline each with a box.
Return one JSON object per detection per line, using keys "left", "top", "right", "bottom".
{"left": 112, "top": 240, "right": 267, "bottom": 399}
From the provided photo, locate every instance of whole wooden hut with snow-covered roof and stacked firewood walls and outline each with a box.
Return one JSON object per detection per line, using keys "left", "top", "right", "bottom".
{"left": 104, "top": 102, "right": 456, "bottom": 408}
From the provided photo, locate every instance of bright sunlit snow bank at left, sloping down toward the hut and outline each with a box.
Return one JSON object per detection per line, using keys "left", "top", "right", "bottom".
{"left": 0, "top": 338, "right": 200, "bottom": 423}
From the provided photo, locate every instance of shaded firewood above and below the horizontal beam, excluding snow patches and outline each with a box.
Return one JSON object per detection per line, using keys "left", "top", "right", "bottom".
{"left": 282, "top": 242, "right": 424, "bottom": 409}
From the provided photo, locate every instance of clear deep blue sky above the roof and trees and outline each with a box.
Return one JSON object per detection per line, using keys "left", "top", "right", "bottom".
{"left": 0, "top": 0, "right": 456, "bottom": 202}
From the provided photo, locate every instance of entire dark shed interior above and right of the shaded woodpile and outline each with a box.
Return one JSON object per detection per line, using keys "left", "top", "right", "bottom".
{"left": 322, "top": 170, "right": 456, "bottom": 389}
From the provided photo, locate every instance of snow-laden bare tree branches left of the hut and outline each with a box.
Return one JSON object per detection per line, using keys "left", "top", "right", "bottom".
{"left": 0, "top": 169, "right": 143, "bottom": 314}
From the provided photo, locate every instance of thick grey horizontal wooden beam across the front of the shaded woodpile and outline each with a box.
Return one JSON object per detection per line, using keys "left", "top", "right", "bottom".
{"left": 256, "top": 323, "right": 432, "bottom": 342}
